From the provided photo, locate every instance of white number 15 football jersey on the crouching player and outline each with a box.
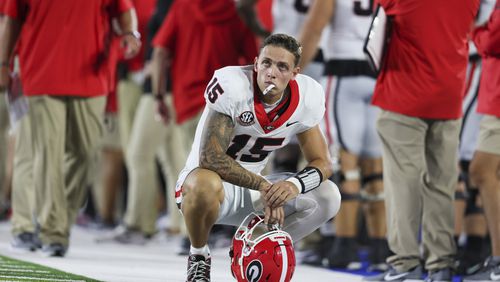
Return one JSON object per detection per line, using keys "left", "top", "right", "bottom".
{"left": 177, "top": 66, "right": 325, "bottom": 193}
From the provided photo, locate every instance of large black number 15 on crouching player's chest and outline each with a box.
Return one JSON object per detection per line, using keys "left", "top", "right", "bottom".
{"left": 226, "top": 134, "right": 285, "bottom": 163}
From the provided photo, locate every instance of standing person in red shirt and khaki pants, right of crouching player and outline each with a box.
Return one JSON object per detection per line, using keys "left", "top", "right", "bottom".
{"left": 365, "top": 0, "right": 479, "bottom": 281}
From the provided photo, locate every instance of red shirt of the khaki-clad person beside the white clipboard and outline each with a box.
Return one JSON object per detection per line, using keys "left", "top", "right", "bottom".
{"left": 373, "top": 0, "right": 479, "bottom": 119}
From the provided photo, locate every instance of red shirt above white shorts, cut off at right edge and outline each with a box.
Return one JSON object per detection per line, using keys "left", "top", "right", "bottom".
{"left": 473, "top": 0, "right": 500, "bottom": 117}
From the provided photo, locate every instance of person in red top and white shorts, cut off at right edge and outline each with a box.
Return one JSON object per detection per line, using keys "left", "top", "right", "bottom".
{"left": 464, "top": 0, "right": 500, "bottom": 282}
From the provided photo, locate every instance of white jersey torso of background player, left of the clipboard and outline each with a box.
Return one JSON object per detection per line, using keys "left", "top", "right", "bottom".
{"left": 323, "top": 0, "right": 373, "bottom": 61}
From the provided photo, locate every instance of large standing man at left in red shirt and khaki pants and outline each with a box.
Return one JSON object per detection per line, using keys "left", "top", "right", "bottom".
{"left": 0, "top": 0, "right": 140, "bottom": 256}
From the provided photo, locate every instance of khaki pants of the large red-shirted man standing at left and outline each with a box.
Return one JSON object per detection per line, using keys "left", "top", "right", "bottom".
{"left": 28, "top": 96, "right": 106, "bottom": 245}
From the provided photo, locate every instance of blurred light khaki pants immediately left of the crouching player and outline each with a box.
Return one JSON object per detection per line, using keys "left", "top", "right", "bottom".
{"left": 124, "top": 95, "right": 199, "bottom": 234}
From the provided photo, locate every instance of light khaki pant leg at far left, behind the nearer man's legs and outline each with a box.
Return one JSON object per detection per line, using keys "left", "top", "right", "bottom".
{"left": 11, "top": 116, "right": 35, "bottom": 235}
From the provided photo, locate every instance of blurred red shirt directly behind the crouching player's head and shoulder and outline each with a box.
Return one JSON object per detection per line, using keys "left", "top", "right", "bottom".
{"left": 152, "top": 0, "right": 257, "bottom": 123}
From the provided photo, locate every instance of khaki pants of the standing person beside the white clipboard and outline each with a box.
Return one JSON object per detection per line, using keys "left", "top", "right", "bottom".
{"left": 377, "top": 111, "right": 461, "bottom": 271}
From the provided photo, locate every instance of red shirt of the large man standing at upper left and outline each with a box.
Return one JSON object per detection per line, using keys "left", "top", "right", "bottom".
{"left": 6, "top": 0, "right": 132, "bottom": 97}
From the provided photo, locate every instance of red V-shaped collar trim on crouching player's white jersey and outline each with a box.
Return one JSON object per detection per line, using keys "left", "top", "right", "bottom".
{"left": 253, "top": 76, "right": 300, "bottom": 133}
